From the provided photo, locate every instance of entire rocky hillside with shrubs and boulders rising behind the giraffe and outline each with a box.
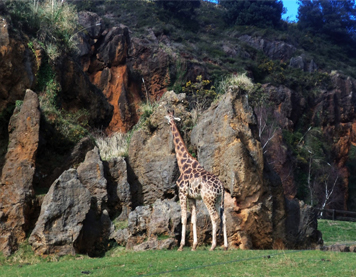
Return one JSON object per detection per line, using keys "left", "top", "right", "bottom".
{"left": 0, "top": 1, "right": 356, "bottom": 256}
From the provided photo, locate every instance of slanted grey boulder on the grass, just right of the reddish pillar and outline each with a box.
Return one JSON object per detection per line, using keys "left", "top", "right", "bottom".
{"left": 29, "top": 169, "right": 91, "bottom": 255}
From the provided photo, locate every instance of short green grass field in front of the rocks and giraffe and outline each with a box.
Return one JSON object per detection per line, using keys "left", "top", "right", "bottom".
{"left": 0, "top": 220, "right": 356, "bottom": 277}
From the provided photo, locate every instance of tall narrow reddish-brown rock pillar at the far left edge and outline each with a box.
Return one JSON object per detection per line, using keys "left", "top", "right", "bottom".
{"left": 0, "top": 90, "right": 40, "bottom": 255}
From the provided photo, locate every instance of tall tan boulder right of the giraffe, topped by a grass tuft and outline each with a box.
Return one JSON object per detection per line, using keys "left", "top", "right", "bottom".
{"left": 191, "top": 87, "right": 285, "bottom": 249}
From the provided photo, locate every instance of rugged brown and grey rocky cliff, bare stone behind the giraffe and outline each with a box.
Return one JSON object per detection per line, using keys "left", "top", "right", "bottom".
{"left": 0, "top": 2, "right": 356, "bottom": 256}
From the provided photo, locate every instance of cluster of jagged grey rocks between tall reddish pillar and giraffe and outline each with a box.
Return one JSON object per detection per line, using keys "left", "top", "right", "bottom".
{"left": 29, "top": 147, "right": 130, "bottom": 256}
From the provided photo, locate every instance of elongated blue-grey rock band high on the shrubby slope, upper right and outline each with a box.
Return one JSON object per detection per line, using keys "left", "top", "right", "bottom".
{"left": 239, "top": 35, "right": 297, "bottom": 61}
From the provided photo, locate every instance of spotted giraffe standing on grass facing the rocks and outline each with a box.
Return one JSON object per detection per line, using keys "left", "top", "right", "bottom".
{"left": 165, "top": 111, "right": 228, "bottom": 251}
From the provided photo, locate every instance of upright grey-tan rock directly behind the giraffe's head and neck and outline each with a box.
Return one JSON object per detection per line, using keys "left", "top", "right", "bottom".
{"left": 128, "top": 91, "right": 191, "bottom": 207}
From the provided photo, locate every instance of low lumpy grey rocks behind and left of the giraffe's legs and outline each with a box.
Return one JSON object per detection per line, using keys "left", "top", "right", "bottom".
{"left": 111, "top": 197, "right": 218, "bottom": 251}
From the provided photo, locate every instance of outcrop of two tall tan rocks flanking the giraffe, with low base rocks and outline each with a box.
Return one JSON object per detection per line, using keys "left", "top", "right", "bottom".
{"left": 123, "top": 87, "right": 318, "bottom": 249}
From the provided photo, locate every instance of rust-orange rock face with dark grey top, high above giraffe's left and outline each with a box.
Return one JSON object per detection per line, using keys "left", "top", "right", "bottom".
{"left": 77, "top": 12, "right": 142, "bottom": 133}
